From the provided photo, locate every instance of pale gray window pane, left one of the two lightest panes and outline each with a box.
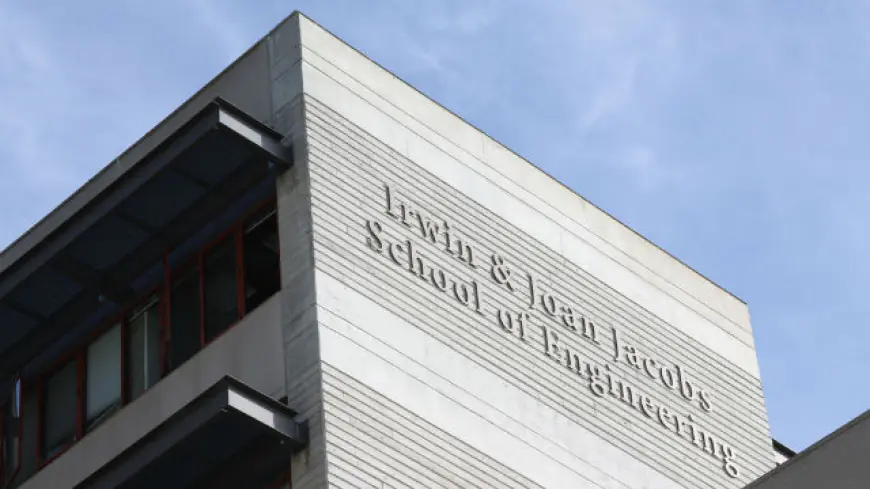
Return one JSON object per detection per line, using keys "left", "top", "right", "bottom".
{"left": 85, "top": 325, "right": 121, "bottom": 431}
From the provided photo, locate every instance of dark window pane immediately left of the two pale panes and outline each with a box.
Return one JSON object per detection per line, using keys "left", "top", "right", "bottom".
{"left": 42, "top": 361, "right": 76, "bottom": 459}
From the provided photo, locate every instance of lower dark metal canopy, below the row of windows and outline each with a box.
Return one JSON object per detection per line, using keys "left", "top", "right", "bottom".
{"left": 75, "top": 377, "right": 308, "bottom": 489}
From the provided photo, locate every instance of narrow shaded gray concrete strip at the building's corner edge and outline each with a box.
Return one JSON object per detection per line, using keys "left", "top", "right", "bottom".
{"left": 265, "top": 15, "right": 327, "bottom": 489}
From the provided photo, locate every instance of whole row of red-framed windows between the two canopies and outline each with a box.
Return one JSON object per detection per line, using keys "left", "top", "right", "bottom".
{"left": 0, "top": 195, "right": 281, "bottom": 488}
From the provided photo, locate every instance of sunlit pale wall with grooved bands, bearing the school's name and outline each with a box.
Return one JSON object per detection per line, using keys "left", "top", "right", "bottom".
{"left": 282, "top": 10, "right": 773, "bottom": 489}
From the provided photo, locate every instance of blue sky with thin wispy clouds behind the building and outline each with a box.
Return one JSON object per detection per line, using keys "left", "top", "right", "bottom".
{"left": 0, "top": 0, "right": 870, "bottom": 449}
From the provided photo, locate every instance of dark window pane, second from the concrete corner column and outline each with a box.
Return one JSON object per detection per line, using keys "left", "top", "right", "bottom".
{"left": 203, "top": 236, "right": 238, "bottom": 341}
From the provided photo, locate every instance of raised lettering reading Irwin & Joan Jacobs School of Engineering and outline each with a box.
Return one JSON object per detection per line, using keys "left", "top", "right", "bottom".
{"left": 364, "top": 184, "right": 740, "bottom": 477}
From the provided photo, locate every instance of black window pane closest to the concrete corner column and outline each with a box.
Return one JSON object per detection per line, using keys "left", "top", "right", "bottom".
{"left": 243, "top": 207, "right": 281, "bottom": 313}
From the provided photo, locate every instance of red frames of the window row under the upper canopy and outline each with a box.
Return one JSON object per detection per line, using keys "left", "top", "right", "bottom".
{"left": 0, "top": 195, "right": 285, "bottom": 480}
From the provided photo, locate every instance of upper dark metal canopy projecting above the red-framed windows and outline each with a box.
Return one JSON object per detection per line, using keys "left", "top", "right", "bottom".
{"left": 0, "top": 99, "right": 292, "bottom": 384}
